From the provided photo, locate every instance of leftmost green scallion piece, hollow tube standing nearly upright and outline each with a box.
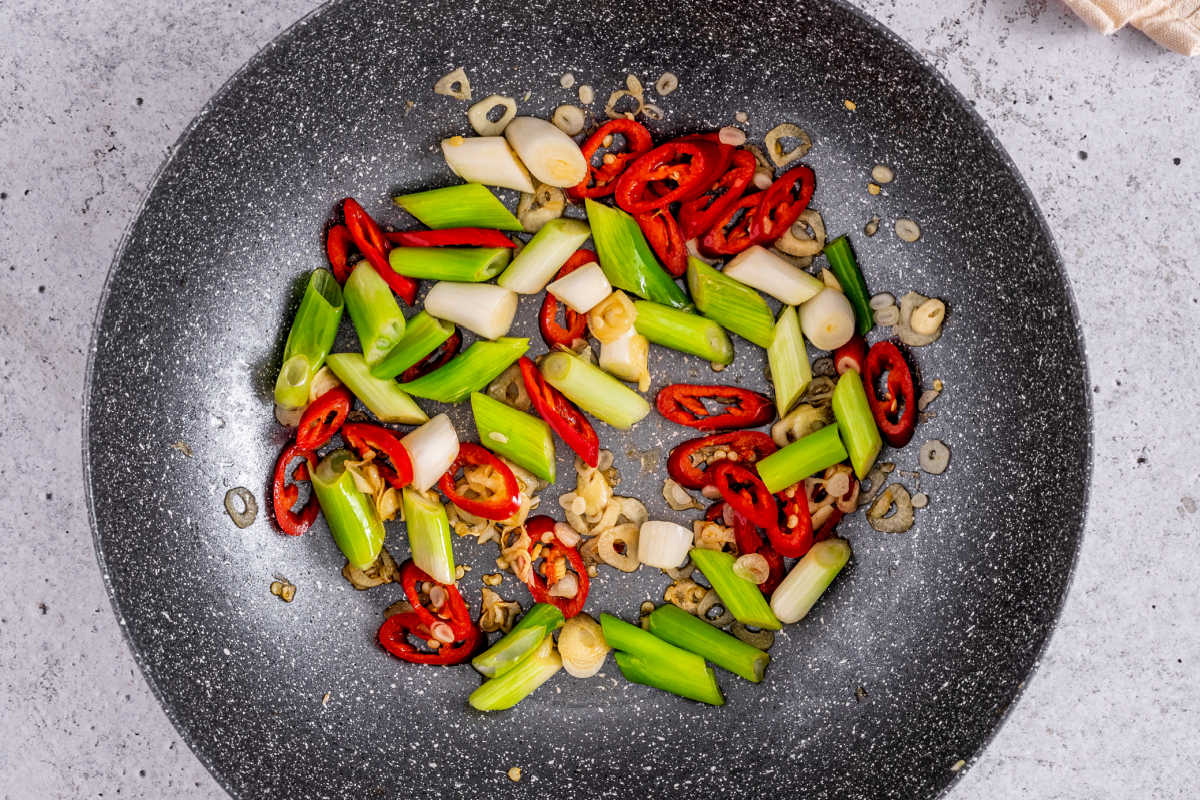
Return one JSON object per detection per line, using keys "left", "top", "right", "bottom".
{"left": 275, "top": 270, "right": 344, "bottom": 408}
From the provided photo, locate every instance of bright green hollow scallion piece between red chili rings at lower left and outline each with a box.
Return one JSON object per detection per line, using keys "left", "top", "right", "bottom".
{"left": 308, "top": 450, "right": 385, "bottom": 570}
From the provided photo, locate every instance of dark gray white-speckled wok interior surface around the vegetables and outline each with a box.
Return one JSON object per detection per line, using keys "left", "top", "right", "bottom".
{"left": 85, "top": 0, "right": 1090, "bottom": 798}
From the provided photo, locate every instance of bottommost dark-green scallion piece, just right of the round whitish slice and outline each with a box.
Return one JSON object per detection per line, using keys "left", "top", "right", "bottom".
{"left": 600, "top": 614, "right": 725, "bottom": 705}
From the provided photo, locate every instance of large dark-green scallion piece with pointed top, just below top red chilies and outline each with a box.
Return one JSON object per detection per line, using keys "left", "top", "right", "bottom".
{"left": 584, "top": 198, "right": 691, "bottom": 308}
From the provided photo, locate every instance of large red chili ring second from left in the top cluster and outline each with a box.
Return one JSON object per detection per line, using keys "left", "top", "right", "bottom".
{"left": 613, "top": 138, "right": 724, "bottom": 215}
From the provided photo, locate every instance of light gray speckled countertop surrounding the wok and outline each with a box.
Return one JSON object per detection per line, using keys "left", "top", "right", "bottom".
{"left": 0, "top": 0, "right": 1200, "bottom": 800}
